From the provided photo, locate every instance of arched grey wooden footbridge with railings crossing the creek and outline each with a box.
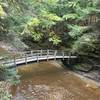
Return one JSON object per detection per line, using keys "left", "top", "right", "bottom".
{"left": 2, "top": 50, "right": 77, "bottom": 66}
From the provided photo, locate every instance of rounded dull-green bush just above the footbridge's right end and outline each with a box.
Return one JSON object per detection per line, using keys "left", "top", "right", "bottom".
{"left": 72, "top": 34, "right": 96, "bottom": 54}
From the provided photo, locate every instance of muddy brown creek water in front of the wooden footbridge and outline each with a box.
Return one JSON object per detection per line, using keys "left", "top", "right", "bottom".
{"left": 11, "top": 61, "right": 100, "bottom": 100}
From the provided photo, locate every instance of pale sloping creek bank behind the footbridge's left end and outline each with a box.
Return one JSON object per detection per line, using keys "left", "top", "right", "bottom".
{"left": 0, "top": 38, "right": 28, "bottom": 55}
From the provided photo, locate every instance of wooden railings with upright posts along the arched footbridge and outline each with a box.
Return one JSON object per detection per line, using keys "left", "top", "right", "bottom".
{"left": 0, "top": 50, "right": 76, "bottom": 64}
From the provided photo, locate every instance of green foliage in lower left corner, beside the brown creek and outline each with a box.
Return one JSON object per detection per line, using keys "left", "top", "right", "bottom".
{"left": 0, "top": 57, "right": 20, "bottom": 100}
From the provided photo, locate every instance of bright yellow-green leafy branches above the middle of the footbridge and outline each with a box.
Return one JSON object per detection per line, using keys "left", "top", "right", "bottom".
{"left": 23, "top": 11, "right": 62, "bottom": 45}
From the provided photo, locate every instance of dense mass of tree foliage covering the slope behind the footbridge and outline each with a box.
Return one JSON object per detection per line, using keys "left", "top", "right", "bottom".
{"left": 0, "top": 0, "right": 100, "bottom": 56}
